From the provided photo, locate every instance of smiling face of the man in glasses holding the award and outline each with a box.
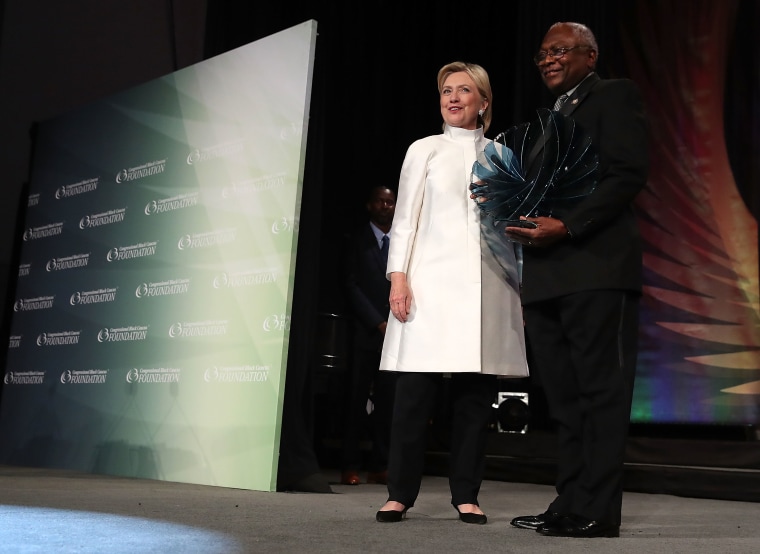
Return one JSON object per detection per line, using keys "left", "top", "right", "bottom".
{"left": 538, "top": 25, "right": 596, "bottom": 96}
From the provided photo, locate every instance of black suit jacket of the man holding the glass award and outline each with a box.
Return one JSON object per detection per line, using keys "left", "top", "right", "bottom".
{"left": 522, "top": 74, "right": 649, "bottom": 304}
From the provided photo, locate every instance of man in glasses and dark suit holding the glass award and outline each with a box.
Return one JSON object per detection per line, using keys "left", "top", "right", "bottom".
{"left": 507, "top": 23, "right": 648, "bottom": 537}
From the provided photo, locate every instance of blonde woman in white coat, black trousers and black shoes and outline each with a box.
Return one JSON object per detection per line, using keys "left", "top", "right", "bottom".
{"left": 376, "top": 62, "right": 528, "bottom": 524}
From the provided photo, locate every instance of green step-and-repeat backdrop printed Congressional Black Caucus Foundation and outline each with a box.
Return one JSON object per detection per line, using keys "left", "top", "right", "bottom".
{"left": 0, "top": 21, "right": 317, "bottom": 490}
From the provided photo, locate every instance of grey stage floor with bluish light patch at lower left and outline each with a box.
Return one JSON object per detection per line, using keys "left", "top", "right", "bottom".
{"left": 0, "top": 466, "right": 760, "bottom": 554}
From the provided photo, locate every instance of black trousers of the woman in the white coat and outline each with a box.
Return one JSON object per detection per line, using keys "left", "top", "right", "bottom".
{"left": 388, "top": 372, "right": 497, "bottom": 508}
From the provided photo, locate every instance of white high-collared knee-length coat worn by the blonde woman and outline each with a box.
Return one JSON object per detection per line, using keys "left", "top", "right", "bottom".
{"left": 380, "top": 125, "right": 528, "bottom": 377}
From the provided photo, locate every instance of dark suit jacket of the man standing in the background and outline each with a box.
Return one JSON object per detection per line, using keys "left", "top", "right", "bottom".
{"left": 346, "top": 223, "right": 391, "bottom": 351}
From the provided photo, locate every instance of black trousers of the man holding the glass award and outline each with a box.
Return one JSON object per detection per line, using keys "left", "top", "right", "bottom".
{"left": 524, "top": 290, "right": 639, "bottom": 524}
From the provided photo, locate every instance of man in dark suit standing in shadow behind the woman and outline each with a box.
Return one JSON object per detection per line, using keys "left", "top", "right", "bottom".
{"left": 341, "top": 186, "right": 396, "bottom": 485}
